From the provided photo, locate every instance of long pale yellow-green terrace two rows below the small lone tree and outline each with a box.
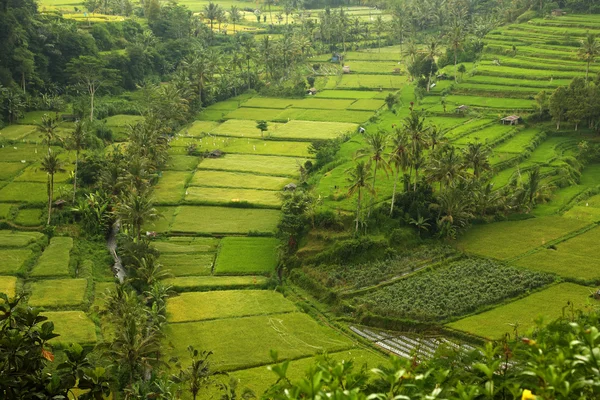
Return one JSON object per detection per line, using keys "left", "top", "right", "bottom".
{"left": 199, "top": 154, "right": 306, "bottom": 177}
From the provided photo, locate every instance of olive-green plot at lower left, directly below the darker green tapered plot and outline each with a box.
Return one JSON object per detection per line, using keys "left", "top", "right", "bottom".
{"left": 28, "top": 279, "right": 87, "bottom": 308}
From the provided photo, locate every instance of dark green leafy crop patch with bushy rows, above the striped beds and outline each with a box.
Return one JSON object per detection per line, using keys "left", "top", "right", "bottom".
{"left": 354, "top": 258, "right": 555, "bottom": 321}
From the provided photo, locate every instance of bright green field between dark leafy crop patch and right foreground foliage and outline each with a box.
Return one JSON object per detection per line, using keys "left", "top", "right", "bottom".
{"left": 448, "top": 283, "right": 597, "bottom": 339}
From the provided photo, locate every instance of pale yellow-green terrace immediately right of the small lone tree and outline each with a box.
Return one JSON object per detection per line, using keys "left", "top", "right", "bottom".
{"left": 276, "top": 121, "right": 357, "bottom": 140}
